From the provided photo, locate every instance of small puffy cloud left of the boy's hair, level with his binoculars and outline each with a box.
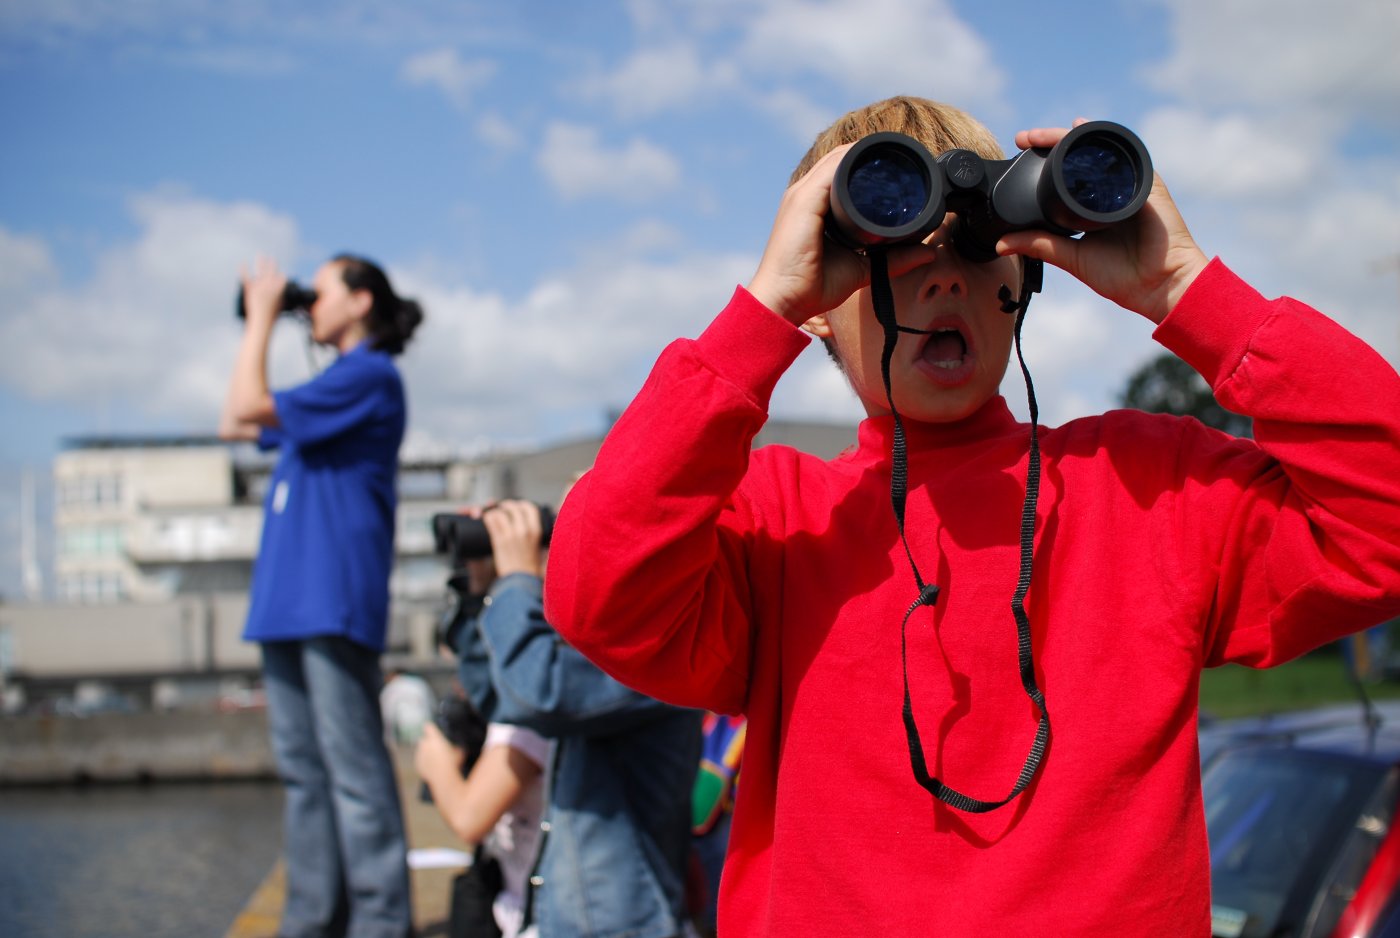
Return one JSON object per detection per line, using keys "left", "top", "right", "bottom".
{"left": 538, "top": 122, "right": 680, "bottom": 202}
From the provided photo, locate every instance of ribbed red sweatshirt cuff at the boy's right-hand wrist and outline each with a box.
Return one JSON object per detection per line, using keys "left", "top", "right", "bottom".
{"left": 1152, "top": 258, "right": 1273, "bottom": 389}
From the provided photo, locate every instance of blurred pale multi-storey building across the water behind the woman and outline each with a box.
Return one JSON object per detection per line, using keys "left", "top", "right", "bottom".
{"left": 53, "top": 420, "right": 855, "bottom": 605}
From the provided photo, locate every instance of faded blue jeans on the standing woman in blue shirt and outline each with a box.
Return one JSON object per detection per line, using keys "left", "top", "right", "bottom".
{"left": 262, "top": 637, "right": 413, "bottom": 938}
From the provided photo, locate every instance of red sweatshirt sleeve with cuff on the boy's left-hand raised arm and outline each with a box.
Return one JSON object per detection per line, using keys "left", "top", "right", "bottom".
{"left": 545, "top": 288, "right": 809, "bottom": 713}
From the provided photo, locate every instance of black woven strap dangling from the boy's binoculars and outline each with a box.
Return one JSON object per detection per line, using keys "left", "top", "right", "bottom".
{"left": 869, "top": 249, "right": 1050, "bottom": 813}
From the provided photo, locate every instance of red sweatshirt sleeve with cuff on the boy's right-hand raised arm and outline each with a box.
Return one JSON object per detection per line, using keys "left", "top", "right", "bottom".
{"left": 1155, "top": 260, "right": 1400, "bottom": 666}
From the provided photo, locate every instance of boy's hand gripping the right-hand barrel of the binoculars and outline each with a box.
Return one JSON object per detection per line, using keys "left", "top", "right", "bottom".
{"left": 997, "top": 119, "right": 1208, "bottom": 323}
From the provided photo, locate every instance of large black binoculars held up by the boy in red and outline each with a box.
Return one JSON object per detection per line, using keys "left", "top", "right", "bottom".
{"left": 826, "top": 120, "right": 1152, "bottom": 263}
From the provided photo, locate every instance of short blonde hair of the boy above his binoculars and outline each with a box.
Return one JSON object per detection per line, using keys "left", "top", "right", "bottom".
{"left": 790, "top": 95, "right": 1004, "bottom": 182}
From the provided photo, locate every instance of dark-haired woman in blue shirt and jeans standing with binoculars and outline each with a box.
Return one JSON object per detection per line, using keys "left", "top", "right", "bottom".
{"left": 220, "top": 255, "right": 423, "bottom": 938}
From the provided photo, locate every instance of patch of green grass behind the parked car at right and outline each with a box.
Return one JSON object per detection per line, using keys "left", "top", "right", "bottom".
{"left": 1201, "top": 654, "right": 1400, "bottom": 717}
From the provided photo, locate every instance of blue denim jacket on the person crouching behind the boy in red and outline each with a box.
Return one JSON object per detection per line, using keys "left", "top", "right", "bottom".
{"left": 456, "top": 574, "right": 701, "bottom": 938}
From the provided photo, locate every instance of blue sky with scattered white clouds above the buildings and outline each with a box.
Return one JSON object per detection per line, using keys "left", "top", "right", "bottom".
{"left": 0, "top": 0, "right": 1400, "bottom": 595}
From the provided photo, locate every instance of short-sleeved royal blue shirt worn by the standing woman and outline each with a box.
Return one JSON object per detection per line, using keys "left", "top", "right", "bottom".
{"left": 244, "top": 343, "right": 407, "bottom": 651}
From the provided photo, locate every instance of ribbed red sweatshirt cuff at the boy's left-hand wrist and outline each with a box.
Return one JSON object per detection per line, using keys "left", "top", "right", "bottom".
{"left": 696, "top": 286, "right": 812, "bottom": 409}
